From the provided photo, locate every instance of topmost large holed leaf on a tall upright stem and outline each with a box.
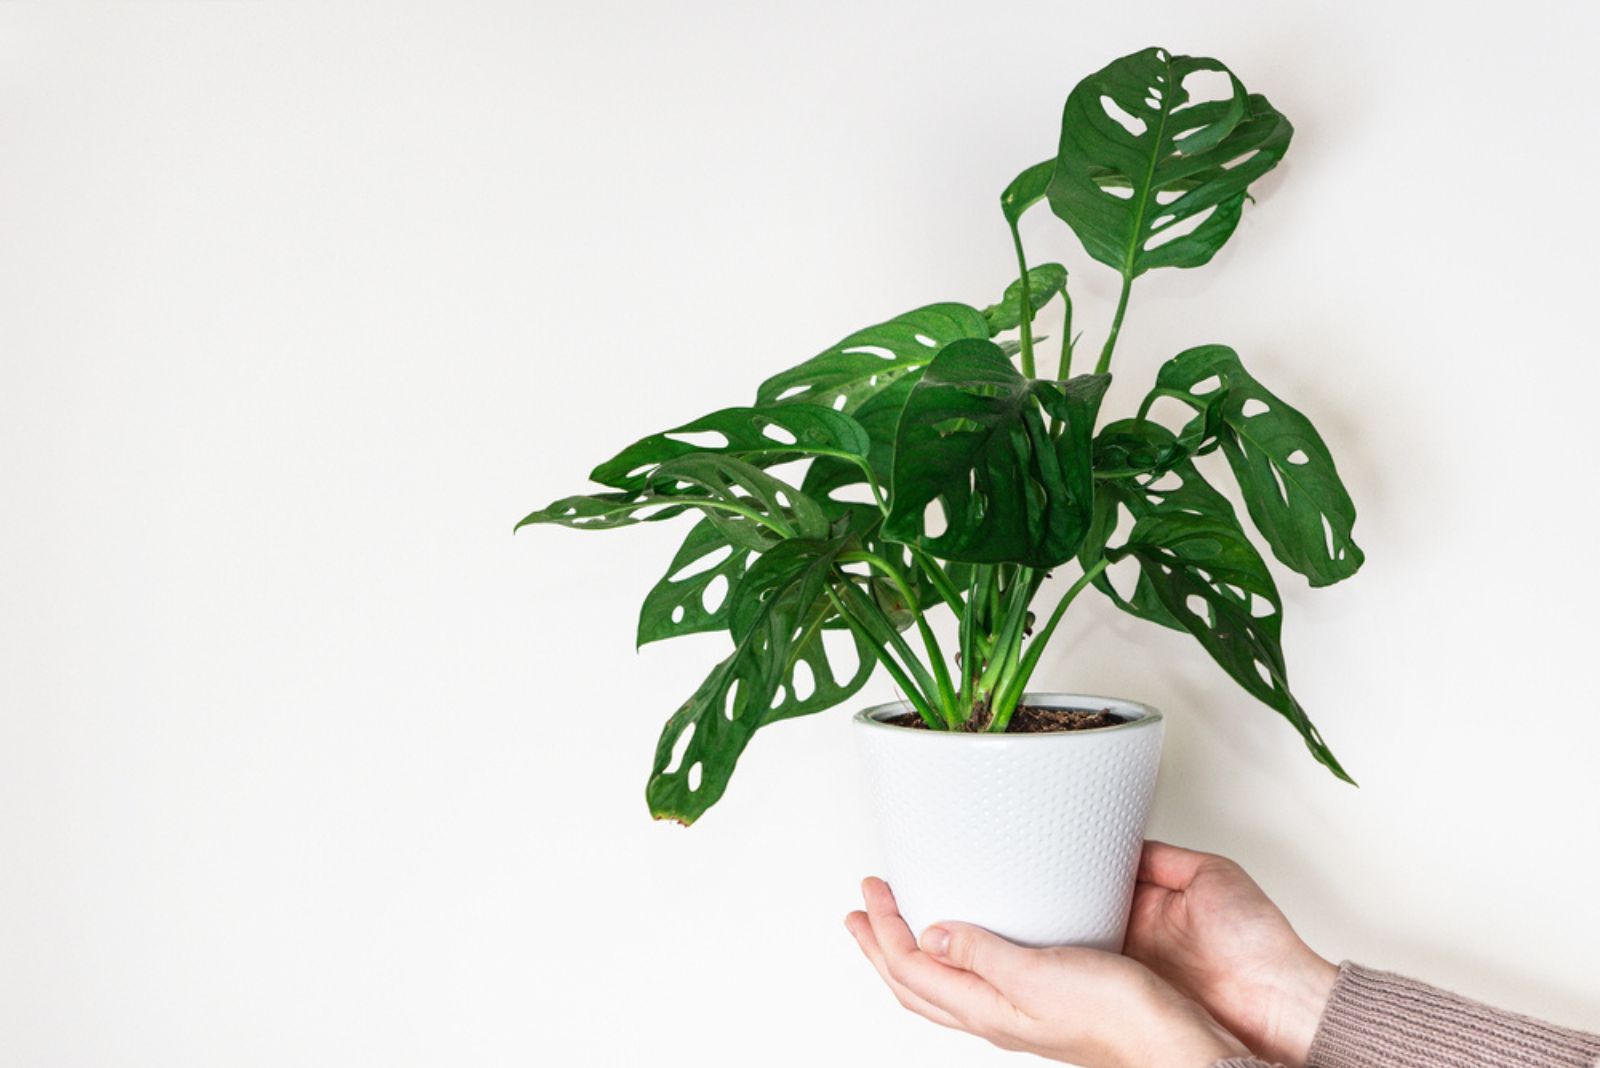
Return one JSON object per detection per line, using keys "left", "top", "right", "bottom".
{"left": 1048, "top": 48, "right": 1293, "bottom": 280}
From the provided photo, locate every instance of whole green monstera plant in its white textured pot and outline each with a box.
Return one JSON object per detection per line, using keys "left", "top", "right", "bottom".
{"left": 517, "top": 48, "right": 1362, "bottom": 948}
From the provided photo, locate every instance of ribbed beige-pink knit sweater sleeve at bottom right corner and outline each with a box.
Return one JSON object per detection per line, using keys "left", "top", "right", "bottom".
{"left": 1306, "top": 961, "right": 1600, "bottom": 1068}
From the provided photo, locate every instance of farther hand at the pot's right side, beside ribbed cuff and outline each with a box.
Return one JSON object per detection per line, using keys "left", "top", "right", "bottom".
{"left": 1123, "top": 841, "right": 1339, "bottom": 1068}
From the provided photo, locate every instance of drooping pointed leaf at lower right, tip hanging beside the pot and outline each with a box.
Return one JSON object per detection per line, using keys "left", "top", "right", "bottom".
{"left": 1107, "top": 513, "right": 1355, "bottom": 783}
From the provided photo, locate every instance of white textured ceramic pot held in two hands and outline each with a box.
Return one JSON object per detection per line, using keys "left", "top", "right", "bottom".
{"left": 854, "top": 694, "right": 1163, "bottom": 951}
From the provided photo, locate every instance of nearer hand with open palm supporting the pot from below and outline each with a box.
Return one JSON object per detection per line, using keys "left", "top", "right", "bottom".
{"left": 845, "top": 879, "right": 1246, "bottom": 1068}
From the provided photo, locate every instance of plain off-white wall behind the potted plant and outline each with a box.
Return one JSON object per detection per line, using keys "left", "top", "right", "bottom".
{"left": 0, "top": 0, "right": 1600, "bottom": 1068}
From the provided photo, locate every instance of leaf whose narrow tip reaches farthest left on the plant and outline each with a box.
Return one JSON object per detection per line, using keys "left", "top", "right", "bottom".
{"left": 515, "top": 452, "right": 827, "bottom": 552}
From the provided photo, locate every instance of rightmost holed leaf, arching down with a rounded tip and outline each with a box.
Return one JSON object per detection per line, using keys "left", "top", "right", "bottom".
{"left": 1155, "top": 345, "right": 1365, "bottom": 585}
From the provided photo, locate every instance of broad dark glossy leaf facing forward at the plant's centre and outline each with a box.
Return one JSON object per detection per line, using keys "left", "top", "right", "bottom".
{"left": 885, "top": 341, "right": 1109, "bottom": 568}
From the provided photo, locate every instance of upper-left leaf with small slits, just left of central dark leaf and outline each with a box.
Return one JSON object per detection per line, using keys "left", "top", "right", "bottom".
{"left": 755, "top": 304, "right": 989, "bottom": 414}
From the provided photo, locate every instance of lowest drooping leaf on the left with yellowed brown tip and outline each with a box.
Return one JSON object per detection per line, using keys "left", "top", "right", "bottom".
{"left": 645, "top": 537, "right": 870, "bottom": 823}
